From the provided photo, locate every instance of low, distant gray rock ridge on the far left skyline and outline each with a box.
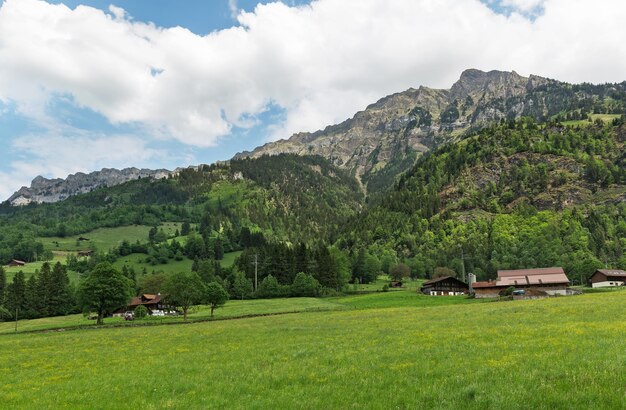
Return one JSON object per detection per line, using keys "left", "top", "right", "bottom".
{"left": 8, "top": 168, "right": 176, "bottom": 206}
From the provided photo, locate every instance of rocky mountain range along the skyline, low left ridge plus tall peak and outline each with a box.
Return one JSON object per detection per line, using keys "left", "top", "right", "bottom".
{"left": 8, "top": 69, "right": 626, "bottom": 205}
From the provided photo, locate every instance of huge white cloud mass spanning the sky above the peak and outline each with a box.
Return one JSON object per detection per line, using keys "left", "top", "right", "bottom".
{"left": 0, "top": 0, "right": 626, "bottom": 149}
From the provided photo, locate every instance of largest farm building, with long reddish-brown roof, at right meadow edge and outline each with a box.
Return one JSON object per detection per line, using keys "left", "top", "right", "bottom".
{"left": 472, "top": 267, "right": 569, "bottom": 298}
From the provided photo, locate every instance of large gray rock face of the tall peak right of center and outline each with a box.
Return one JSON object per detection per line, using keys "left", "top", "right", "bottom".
{"left": 235, "top": 69, "right": 552, "bottom": 188}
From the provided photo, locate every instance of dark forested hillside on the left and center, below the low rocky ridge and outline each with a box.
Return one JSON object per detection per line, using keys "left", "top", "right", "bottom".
{"left": 0, "top": 155, "right": 363, "bottom": 264}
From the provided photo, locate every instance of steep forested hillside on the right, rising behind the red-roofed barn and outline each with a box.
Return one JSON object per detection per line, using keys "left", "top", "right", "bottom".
{"left": 339, "top": 117, "right": 626, "bottom": 280}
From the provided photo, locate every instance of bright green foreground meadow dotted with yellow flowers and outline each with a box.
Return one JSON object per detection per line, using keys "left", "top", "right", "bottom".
{"left": 0, "top": 292, "right": 626, "bottom": 409}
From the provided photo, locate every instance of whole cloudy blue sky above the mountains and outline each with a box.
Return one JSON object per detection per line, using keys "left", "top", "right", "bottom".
{"left": 0, "top": 0, "right": 626, "bottom": 200}
